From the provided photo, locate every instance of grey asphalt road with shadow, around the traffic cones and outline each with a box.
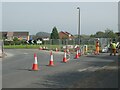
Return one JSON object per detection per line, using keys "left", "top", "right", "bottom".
{"left": 2, "top": 49, "right": 118, "bottom": 88}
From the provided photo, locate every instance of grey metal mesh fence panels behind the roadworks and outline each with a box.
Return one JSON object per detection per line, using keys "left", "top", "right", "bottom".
{"left": 43, "top": 38, "right": 110, "bottom": 49}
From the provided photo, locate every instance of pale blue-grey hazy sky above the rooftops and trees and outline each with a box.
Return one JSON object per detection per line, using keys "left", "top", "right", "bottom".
{"left": 2, "top": 2, "right": 118, "bottom": 35}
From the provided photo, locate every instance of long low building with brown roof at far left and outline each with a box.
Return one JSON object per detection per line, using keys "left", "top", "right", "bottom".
{"left": 0, "top": 32, "right": 29, "bottom": 41}
